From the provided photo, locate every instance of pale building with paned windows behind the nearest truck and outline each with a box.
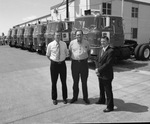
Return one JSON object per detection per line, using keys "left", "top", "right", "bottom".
{"left": 50, "top": 0, "right": 150, "bottom": 44}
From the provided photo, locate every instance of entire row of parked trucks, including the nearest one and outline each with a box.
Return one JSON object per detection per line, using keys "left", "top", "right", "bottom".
{"left": 8, "top": 13, "right": 150, "bottom": 60}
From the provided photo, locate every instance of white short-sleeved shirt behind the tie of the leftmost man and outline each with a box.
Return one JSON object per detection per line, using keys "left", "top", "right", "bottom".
{"left": 46, "top": 40, "right": 68, "bottom": 62}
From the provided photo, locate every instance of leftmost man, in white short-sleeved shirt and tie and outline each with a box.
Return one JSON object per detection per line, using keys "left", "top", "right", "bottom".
{"left": 46, "top": 32, "right": 68, "bottom": 105}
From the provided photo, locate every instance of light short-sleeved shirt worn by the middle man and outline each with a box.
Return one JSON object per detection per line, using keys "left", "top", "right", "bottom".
{"left": 69, "top": 39, "right": 90, "bottom": 60}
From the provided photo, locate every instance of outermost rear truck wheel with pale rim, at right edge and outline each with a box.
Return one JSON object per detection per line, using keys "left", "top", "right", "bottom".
{"left": 139, "top": 45, "right": 150, "bottom": 60}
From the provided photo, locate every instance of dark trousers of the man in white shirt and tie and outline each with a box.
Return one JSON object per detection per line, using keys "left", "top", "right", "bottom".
{"left": 50, "top": 61, "right": 67, "bottom": 100}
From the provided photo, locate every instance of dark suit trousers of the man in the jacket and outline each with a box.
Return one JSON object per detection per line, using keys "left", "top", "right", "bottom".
{"left": 99, "top": 78, "right": 114, "bottom": 109}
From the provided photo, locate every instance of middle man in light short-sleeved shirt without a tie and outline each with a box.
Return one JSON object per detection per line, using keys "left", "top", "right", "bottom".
{"left": 69, "top": 30, "right": 90, "bottom": 104}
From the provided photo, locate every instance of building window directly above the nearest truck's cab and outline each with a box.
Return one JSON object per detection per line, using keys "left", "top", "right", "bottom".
{"left": 102, "top": 3, "right": 111, "bottom": 15}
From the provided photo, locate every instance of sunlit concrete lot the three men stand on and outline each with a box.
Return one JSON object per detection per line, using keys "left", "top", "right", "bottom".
{"left": 0, "top": 46, "right": 150, "bottom": 124}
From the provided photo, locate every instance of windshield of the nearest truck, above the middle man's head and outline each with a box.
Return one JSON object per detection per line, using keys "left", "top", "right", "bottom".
{"left": 73, "top": 17, "right": 95, "bottom": 29}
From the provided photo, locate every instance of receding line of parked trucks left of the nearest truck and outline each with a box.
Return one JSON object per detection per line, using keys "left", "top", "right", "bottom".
{"left": 7, "top": 21, "right": 73, "bottom": 54}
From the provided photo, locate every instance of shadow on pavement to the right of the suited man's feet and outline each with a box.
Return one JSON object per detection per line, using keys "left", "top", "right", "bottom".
{"left": 114, "top": 98, "right": 148, "bottom": 113}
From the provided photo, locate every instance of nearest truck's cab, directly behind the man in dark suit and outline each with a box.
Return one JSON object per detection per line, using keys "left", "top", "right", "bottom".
{"left": 72, "top": 14, "right": 135, "bottom": 60}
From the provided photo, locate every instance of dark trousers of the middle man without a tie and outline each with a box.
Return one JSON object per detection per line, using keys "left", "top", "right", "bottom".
{"left": 71, "top": 59, "right": 89, "bottom": 99}
